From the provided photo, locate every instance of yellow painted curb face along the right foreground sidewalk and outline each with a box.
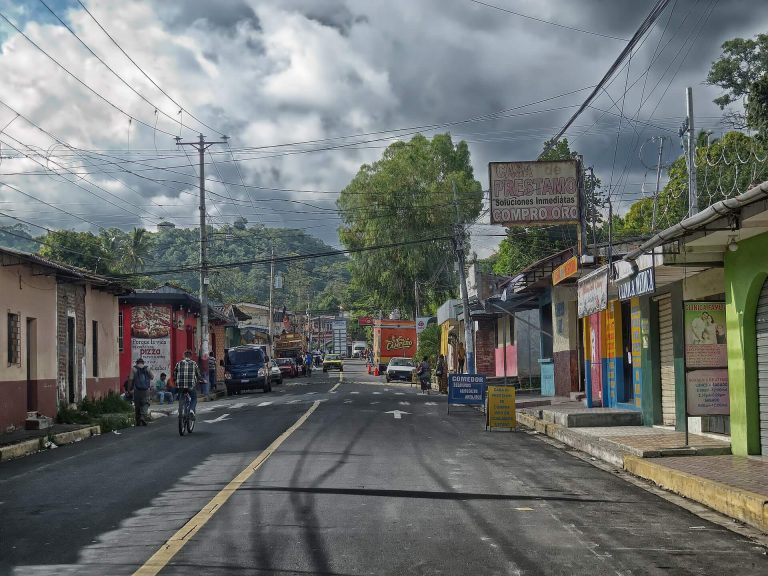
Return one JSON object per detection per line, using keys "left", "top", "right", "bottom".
{"left": 624, "top": 456, "right": 768, "bottom": 532}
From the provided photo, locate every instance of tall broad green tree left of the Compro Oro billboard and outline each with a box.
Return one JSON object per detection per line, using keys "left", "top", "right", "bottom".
{"left": 337, "top": 134, "right": 482, "bottom": 314}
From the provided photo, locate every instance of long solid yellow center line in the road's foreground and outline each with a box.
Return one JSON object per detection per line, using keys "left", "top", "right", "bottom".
{"left": 133, "top": 400, "right": 320, "bottom": 576}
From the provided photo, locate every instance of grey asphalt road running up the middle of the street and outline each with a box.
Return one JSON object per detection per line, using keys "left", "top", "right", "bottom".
{"left": 0, "top": 361, "right": 768, "bottom": 576}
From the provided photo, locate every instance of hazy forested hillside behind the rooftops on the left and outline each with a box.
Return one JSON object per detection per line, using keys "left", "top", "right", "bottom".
{"left": 0, "top": 223, "right": 349, "bottom": 313}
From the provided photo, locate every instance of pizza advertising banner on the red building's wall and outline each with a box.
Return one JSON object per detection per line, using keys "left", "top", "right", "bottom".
{"left": 131, "top": 306, "right": 171, "bottom": 377}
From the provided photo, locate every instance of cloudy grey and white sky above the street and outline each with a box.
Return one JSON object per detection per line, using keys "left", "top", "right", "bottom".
{"left": 0, "top": 0, "right": 768, "bottom": 255}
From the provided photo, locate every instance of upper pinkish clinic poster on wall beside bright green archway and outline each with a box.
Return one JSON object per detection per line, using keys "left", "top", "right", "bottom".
{"left": 685, "top": 302, "right": 728, "bottom": 368}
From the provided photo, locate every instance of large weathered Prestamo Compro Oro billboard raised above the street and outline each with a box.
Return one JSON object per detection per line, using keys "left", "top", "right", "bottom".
{"left": 488, "top": 160, "right": 579, "bottom": 226}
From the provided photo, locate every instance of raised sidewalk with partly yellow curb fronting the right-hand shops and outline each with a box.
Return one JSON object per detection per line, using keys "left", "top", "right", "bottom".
{"left": 517, "top": 402, "right": 768, "bottom": 533}
